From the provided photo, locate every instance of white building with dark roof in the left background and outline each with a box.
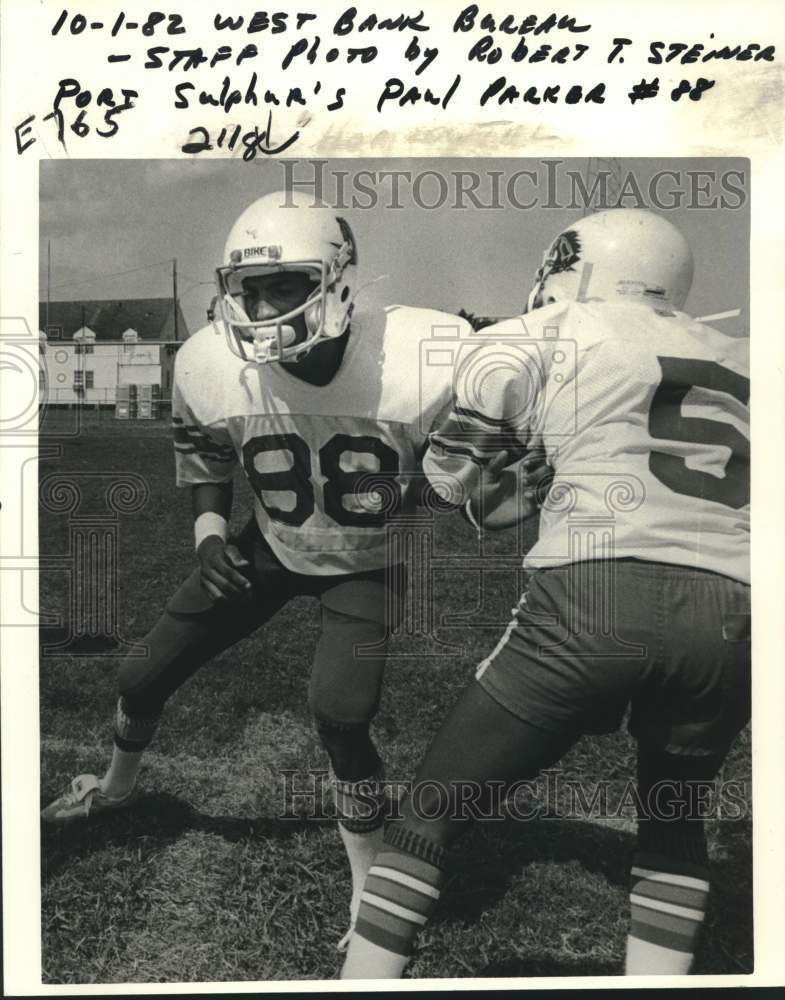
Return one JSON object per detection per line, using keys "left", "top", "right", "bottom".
{"left": 39, "top": 299, "right": 188, "bottom": 406}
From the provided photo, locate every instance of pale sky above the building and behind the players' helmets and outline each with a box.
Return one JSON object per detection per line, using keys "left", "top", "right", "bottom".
{"left": 39, "top": 157, "right": 750, "bottom": 334}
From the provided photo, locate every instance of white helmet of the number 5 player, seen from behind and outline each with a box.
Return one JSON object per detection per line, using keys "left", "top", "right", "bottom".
{"left": 527, "top": 208, "right": 693, "bottom": 311}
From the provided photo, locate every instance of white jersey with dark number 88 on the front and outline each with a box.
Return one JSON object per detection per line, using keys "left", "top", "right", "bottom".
{"left": 172, "top": 306, "right": 471, "bottom": 575}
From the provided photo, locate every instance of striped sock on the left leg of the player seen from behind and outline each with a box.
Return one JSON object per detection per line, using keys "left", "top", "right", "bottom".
{"left": 341, "top": 823, "right": 446, "bottom": 979}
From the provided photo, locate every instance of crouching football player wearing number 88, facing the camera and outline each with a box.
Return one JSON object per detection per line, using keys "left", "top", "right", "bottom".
{"left": 44, "top": 192, "right": 471, "bottom": 948}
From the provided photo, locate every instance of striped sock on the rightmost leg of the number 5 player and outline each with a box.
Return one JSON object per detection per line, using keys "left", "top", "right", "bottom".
{"left": 625, "top": 853, "right": 709, "bottom": 976}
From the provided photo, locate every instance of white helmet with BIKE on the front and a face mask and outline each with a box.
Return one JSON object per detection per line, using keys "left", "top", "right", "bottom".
{"left": 216, "top": 191, "right": 357, "bottom": 364}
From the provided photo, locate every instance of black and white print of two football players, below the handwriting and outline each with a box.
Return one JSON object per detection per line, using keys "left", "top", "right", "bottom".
{"left": 39, "top": 157, "right": 754, "bottom": 984}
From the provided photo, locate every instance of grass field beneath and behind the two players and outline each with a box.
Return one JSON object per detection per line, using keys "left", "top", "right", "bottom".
{"left": 40, "top": 417, "right": 753, "bottom": 983}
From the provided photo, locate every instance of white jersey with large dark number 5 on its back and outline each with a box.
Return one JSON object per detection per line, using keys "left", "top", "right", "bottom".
{"left": 423, "top": 302, "right": 750, "bottom": 582}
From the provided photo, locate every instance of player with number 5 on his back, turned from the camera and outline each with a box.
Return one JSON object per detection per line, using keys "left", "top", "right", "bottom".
{"left": 342, "top": 209, "right": 750, "bottom": 978}
